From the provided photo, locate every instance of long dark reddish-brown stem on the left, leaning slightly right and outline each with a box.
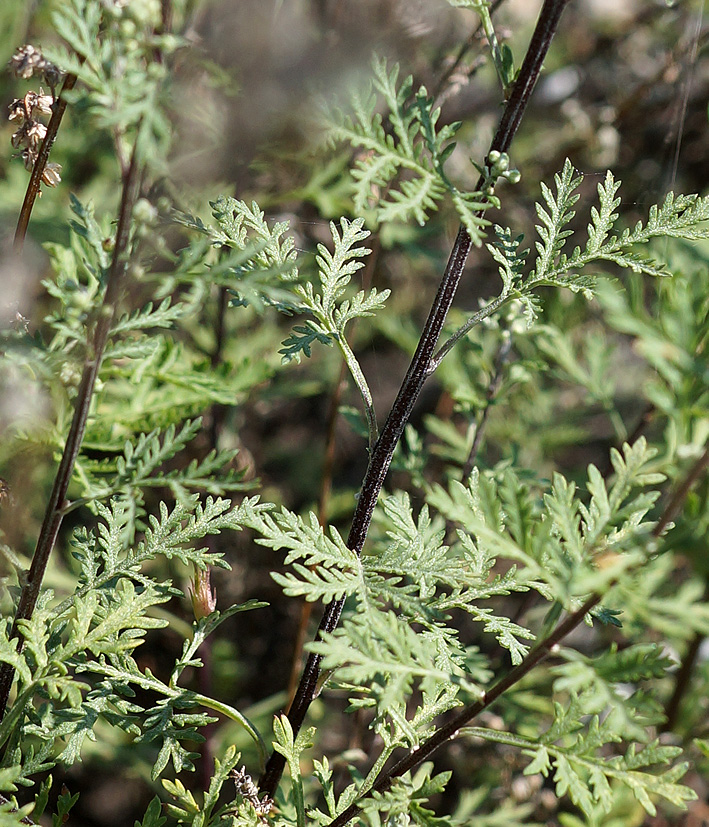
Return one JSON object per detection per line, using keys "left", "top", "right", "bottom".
{"left": 0, "top": 132, "right": 140, "bottom": 719}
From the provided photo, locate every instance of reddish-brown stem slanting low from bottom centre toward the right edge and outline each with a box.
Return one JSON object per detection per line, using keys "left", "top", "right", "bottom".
{"left": 328, "top": 449, "right": 709, "bottom": 827}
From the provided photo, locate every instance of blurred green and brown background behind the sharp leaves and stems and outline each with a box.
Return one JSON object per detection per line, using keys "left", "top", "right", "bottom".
{"left": 0, "top": 0, "right": 709, "bottom": 827}
